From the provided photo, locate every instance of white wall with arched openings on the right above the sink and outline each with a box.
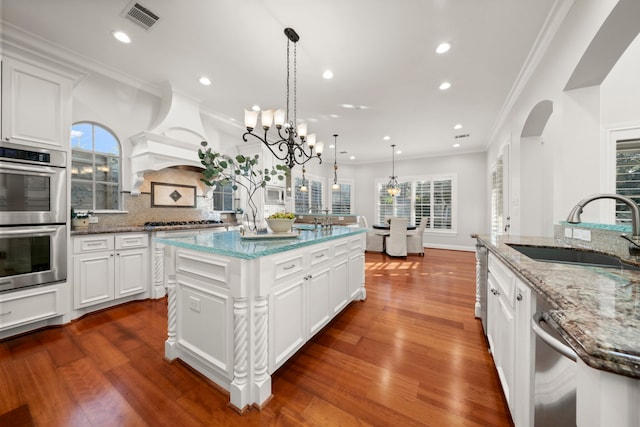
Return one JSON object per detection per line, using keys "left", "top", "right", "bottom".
{"left": 487, "top": 0, "right": 640, "bottom": 235}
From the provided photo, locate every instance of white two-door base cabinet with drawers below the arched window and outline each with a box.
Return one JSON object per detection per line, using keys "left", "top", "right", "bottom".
{"left": 73, "top": 233, "right": 149, "bottom": 309}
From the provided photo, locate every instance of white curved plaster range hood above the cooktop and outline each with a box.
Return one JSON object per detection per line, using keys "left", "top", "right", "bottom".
{"left": 130, "top": 85, "right": 218, "bottom": 195}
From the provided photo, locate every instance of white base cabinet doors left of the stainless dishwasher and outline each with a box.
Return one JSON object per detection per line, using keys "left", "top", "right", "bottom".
{"left": 487, "top": 253, "right": 535, "bottom": 427}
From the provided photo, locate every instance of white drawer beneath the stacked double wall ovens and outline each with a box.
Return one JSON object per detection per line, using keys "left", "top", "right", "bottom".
{"left": 0, "top": 288, "right": 59, "bottom": 331}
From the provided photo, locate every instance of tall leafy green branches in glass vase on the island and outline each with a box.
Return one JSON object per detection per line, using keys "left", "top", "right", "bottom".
{"left": 198, "top": 141, "right": 289, "bottom": 232}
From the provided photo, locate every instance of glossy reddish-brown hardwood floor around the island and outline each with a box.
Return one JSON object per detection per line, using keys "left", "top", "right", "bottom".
{"left": 0, "top": 250, "right": 511, "bottom": 427}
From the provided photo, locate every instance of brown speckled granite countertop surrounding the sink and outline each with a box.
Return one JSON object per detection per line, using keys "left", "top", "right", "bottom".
{"left": 474, "top": 236, "right": 640, "bottom": 379}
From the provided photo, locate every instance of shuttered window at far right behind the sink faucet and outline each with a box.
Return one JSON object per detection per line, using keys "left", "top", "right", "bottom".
{"left": 616, "top": 139, "right": 640, "bottom": 224}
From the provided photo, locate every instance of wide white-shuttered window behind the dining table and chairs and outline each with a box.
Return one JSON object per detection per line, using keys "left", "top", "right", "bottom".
{"left": 376, "top": 175, "right": 456, "bottom": 232}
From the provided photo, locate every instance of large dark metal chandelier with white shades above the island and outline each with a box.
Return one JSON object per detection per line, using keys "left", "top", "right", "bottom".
{"left": 242, "top": 28, "right": 324, "bottom": 169}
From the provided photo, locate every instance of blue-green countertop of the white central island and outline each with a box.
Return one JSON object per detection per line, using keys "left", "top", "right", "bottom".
{"left": 155, "top": 226, "right": 366, "bottom": 259}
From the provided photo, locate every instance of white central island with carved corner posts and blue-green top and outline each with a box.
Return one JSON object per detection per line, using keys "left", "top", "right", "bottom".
{"left": 156, "top": 227, "right": 366, "bottom": 413}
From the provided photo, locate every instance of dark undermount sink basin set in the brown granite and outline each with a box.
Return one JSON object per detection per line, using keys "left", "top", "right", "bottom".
{"left": 507, "top": 244, "right": 640, "bottom": 271}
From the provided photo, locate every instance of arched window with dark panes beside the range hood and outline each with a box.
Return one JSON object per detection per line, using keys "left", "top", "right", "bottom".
{"left": 71, "top": 122, "right": 122, "bottom": 211}
